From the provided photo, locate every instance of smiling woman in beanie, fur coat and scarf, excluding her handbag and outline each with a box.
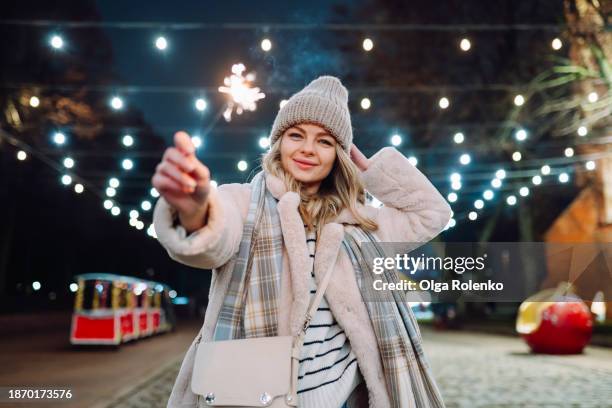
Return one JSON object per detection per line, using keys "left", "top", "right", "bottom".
{"left": 152, "top": 76, "right": 451, "bottom": 408}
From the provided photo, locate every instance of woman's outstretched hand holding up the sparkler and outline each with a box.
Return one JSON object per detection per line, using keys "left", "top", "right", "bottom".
{"left": 151, "top": 131, "right": 210, "bottom": 231}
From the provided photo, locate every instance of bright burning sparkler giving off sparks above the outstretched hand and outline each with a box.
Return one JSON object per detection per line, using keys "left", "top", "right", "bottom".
{"left": 219, "top": 64, "right": 266, "bottom": 122}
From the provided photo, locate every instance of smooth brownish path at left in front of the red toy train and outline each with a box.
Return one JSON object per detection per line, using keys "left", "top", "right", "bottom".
{"left": 0, "top": 313, "right": 200, "bottom": 408}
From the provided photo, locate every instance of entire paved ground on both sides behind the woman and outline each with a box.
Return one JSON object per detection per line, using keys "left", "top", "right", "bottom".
{"left": 0, "top": 314, "right": 612, "bottom": 408}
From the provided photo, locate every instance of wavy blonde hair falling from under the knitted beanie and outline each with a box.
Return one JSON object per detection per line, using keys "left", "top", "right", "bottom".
{"left": 262, "top": 132, "right": 378, "bottom": 236}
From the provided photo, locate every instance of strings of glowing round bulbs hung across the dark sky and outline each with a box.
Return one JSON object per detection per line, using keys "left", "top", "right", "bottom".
{"left": 0, "top": 20, "right": 608, "bottom": 236}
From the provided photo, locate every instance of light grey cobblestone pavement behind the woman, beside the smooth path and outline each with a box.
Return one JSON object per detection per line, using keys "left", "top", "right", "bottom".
{"left": 109, "top": 328, "right": 612, "bottom": 408}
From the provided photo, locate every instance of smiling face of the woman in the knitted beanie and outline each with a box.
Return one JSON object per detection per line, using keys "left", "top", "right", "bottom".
{"left": 280, "top": 123, "right": 337, "bottom": 194}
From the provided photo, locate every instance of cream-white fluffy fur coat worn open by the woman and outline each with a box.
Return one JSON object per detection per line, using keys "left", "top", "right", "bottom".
{"left": 154, "top": 147, "right": 451, "bottom": 408}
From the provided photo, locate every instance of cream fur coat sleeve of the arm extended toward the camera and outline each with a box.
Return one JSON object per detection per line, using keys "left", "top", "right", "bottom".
{"left": 153, "top": 184, "right": 250, "bottom": 269}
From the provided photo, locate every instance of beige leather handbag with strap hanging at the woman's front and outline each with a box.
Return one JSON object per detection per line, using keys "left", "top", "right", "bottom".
{"left": 191, "top": 263, "right": 334, "bottom": 408}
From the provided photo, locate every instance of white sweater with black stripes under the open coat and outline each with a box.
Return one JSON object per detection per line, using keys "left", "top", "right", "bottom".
{"left": 297, "top": 231, "right": 363, "bottom": 408}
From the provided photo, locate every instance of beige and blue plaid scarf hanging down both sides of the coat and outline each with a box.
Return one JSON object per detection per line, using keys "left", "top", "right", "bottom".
{"left": 213, "top": 172, "right": 444, "bottom": 408}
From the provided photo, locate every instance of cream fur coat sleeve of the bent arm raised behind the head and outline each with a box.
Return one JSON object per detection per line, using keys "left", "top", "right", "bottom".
{"left": 361, "top": 147, "right": 451, "bottom": 243}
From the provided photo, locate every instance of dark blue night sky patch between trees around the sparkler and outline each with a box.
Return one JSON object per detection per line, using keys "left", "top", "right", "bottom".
{"left": 97, "top": 0, "right": 358, "bottom": 159}
